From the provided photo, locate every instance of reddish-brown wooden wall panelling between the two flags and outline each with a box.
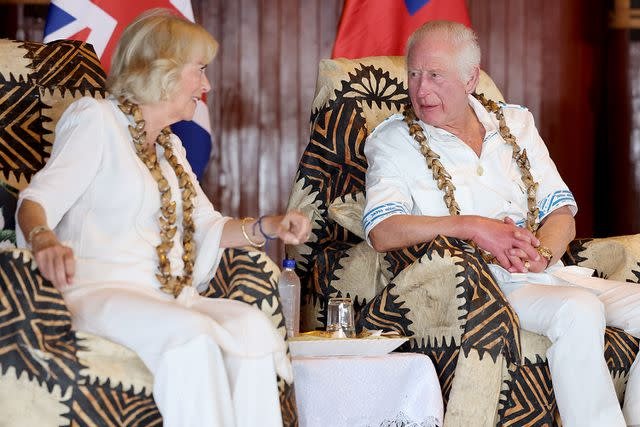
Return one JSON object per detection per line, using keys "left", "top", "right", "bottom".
{"left": 193, "top": 0, "right": 342, "bottom": 258}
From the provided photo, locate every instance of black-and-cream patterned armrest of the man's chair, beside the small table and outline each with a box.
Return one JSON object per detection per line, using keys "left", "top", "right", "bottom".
{"left": 359, "top": 236, "right": 521, "bottom": 363}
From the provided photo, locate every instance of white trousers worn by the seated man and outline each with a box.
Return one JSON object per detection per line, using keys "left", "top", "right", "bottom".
{"left": 505, "top": 279, "right": 640, "bottom": 427}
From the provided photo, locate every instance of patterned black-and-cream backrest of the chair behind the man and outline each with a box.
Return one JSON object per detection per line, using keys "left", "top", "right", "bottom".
{"left": 287, "top": 56, "right": 503, "bottom": 329}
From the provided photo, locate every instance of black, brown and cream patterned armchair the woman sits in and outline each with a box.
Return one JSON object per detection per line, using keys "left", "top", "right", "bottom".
{"left": 0, "top": 40, "right": 297, "bottom": 427}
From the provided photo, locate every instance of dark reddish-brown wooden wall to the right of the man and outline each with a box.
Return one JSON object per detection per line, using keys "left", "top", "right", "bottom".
{"left": 468, "top": 0, "right": 606, "bottom": 236}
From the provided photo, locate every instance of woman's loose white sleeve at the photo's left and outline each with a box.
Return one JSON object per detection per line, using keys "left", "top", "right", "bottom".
{"left": 16, "top": 97, "right": 106, "bottom": 246}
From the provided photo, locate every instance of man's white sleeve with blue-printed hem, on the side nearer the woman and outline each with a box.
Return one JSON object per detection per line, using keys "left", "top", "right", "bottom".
{"left": 362, "top": 129, "right": 413, "bottom": 240}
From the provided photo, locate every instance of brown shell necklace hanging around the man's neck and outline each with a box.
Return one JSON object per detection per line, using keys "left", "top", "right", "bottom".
{"left": 403, "top": 93, "right": 540, "bottom": 233}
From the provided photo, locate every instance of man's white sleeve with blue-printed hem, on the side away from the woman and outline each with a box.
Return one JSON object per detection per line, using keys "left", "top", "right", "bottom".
{"left": 507, "top": 111, "right": 578, "bottom": 221}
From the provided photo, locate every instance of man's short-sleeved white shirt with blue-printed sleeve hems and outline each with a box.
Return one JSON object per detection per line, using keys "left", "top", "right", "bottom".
{"left": 363, "top": 96, "right": 577, "bottom": 236}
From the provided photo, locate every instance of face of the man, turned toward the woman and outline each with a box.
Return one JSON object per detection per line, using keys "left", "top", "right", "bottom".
{"left": 407, "top": 35, "right": 470, "bottom": 129}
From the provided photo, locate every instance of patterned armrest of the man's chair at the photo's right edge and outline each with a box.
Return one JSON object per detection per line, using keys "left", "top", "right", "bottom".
{"left": 562, "top": 234, "right": 640, "bottom": 283}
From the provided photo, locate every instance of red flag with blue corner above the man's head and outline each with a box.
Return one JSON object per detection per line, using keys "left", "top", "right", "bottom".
{"left": 331, "top": 0, "right": 471, "bottom": 58}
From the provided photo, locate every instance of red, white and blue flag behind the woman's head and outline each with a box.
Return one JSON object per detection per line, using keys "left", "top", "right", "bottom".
{"left": 44, "top": 0, "right": 211, "bottom": 179}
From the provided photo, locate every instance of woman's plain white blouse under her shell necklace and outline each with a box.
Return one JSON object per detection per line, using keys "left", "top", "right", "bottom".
{"left": 17, "top": 97, "right": 228, "bottom": 287}
